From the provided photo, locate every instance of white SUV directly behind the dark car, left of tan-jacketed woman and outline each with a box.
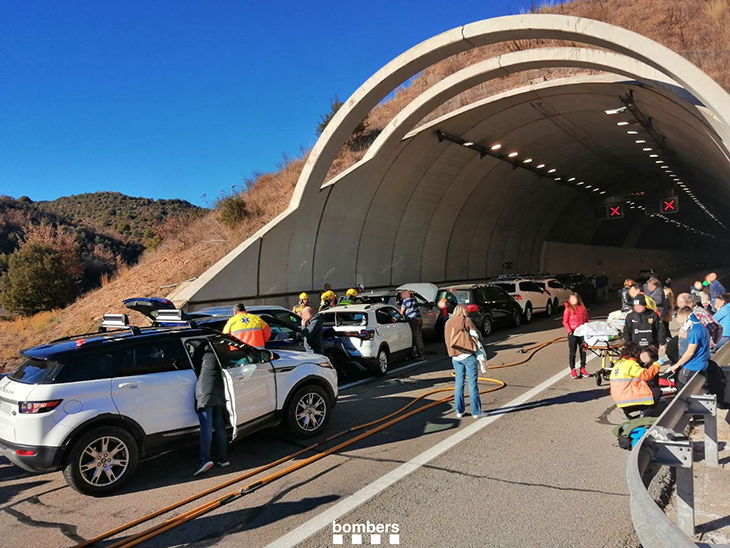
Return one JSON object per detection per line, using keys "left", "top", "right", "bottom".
{"left": 320, "top": 304, "right": 415, "bottom": 376}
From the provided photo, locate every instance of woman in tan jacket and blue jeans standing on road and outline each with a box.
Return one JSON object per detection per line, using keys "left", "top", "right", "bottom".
{"left": 444, "top": 304, "right": 484, "bottom": 419}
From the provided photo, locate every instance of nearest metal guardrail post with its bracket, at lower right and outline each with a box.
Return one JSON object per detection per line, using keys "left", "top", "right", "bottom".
{"left": 646, "top": 438, "right": 695, "bottom": 538}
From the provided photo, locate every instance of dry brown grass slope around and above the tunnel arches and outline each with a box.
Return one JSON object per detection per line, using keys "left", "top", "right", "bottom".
{"left": 0, "top": 0, "right": 730, "bottom": 366}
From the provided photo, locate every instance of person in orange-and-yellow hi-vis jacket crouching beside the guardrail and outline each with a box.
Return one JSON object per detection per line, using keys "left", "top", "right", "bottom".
{"left": 610, "top": 342, "right": 662, "bottom": 418}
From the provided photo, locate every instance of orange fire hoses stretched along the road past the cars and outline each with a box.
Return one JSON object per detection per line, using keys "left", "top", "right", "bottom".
{"left": 76, "top": 337, "right": 566, "bottom": 548}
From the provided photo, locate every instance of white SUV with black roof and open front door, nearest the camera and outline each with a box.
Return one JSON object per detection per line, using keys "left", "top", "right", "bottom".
{"left": 0, "top": 314, "right": 337, "bottom": 496}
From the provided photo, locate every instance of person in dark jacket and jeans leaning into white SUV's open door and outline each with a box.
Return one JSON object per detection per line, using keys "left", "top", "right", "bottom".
{"left": 193, "top": 342, "right": 230, "bottom": 476}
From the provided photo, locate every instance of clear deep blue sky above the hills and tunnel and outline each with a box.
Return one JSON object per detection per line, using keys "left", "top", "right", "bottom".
{"left": 0, "top": 0, "right": 530, "bottom": 205}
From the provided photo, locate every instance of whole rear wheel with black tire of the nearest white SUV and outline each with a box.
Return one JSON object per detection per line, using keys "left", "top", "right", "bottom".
{"left": 63, "top": 425, "right": 139, "bottom": 497}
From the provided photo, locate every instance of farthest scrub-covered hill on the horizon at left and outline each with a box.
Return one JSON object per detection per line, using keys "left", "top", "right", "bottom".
{"left": 34, "top": 192, "right": 203, "bottom": 242}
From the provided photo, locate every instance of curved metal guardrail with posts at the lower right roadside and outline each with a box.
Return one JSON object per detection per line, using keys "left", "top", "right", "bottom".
{"left": 626, "top": 345, "right": 730, "bottom": 548}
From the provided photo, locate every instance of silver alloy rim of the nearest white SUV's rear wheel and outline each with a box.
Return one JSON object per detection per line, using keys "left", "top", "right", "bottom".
{"left": 79, "top": 436, "right": 129, "bottom": 487}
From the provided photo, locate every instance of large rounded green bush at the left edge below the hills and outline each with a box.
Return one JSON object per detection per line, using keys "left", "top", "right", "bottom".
{"left": 0, "top": 243, "right": 78, "bottom": 316}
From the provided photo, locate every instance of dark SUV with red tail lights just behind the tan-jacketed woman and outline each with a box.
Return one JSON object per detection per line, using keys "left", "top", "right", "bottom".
{"left": 437, "top": 284, "right": 522, "bottom": 337}
